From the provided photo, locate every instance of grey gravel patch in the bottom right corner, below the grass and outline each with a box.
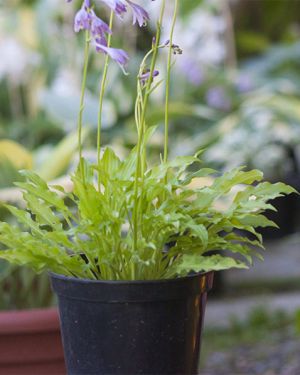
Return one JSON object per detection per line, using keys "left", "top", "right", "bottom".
{"left": 200, "top": 337, "right": 300, "bottom": 375}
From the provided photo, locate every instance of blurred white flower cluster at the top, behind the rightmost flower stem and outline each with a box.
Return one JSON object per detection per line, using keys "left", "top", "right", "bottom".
{"left": 142, "top": 0, "right": 226, "bottom": 86}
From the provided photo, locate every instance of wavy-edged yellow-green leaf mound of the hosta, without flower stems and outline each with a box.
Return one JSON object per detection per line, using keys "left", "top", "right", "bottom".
{"left": 0, "top": 148, "right": 295, "bottom": 280}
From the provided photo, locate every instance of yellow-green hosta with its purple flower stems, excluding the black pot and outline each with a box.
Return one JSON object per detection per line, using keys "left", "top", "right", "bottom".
{"left": 0, "top": 0, "right": 294, "bottom": 280}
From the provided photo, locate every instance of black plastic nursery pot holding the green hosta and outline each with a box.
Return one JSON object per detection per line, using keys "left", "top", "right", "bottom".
{"left": 51, "top": 272, "right": 213, "bottom": 375}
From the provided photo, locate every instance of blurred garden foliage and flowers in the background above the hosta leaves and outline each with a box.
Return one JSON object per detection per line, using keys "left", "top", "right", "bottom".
{"left": 0, "top": 0, "right": 300, "bottom": 310}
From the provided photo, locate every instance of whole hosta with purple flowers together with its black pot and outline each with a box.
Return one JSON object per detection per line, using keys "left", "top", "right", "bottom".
{"left": 0, "top": 0, "right": 294, "bottom": 374}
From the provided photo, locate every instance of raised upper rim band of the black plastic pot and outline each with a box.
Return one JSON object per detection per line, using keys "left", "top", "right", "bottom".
{"left": 50, "top": 272, "right": 213, "bottom": 303}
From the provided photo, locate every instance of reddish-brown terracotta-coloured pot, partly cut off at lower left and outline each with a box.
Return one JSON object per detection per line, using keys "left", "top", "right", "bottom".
{"left": 0, "top": 309, "right": 66, "bottom": 375}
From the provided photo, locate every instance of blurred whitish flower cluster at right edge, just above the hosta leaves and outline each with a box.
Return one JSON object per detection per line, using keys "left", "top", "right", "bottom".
{"left": 205, "top": 102, "right": 300, "bottom": 179}
